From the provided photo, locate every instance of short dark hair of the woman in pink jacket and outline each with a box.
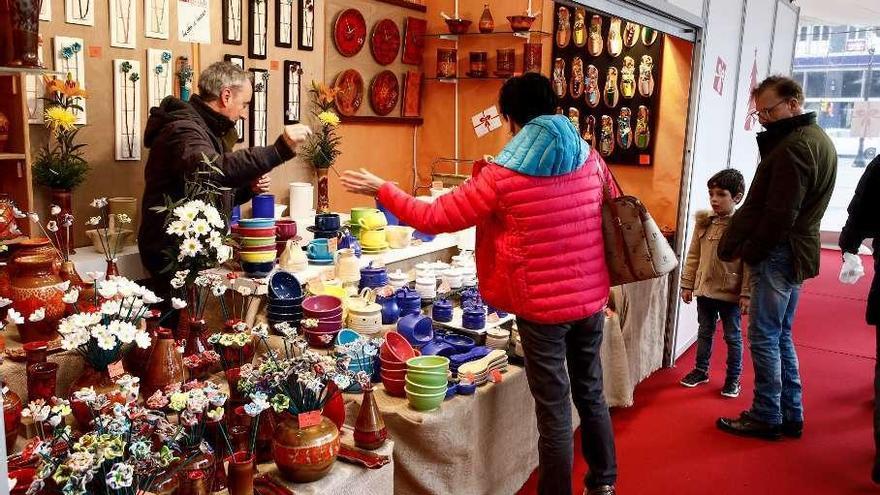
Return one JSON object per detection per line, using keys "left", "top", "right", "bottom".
{"left": 498, "top": 72, "right": 557, "bottom": 127}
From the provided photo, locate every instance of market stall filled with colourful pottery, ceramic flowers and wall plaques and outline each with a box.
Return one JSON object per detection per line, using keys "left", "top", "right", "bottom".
{"left": 0, "top": 0, "right": 796, "bottom": 495}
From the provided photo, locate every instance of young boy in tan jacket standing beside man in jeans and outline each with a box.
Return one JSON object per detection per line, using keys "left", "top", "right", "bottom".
{"left": 681, "top": 168, "right": 749, "bottom": 398}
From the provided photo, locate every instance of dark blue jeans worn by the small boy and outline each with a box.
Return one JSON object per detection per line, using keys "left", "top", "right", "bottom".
{"left": 696, "top": 297, "right": 742, "bottom": 379}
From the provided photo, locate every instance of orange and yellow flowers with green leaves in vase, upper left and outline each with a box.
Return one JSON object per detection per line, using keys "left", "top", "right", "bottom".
{"left": 32, "top": 74, "right": 89, "bottom": 253}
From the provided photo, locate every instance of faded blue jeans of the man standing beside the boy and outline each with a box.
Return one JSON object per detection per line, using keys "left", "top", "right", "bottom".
{"left": 749, "top": 246, "right": 804, "bottom": 425}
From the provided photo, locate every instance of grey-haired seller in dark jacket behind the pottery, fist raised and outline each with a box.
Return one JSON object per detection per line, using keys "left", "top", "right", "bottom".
{"left": 138, "top": 62, "right": 311, "bottom": 281}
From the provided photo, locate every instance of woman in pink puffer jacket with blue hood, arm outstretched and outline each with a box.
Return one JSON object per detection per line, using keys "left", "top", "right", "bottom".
{"left": 342, "top": 73, "right": 617, "bottom": 495}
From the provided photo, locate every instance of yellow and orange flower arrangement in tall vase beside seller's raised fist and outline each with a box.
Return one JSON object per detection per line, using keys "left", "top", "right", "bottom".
{"left": 300, "top": 81, "right": 342, "bottom": 213}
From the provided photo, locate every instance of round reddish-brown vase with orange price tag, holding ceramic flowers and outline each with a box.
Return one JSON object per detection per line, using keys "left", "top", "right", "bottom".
{"left": 272, "top": 412, "right": 340, "bottom": 483}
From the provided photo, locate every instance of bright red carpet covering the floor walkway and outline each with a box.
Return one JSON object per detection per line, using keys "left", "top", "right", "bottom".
{"left": 519, "top": 251, "right": 880, "bottom": 495}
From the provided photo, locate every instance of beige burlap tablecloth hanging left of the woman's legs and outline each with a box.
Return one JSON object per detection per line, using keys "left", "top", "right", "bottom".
{"left": 345, "top": 365, "right": 538, "bottom": 495}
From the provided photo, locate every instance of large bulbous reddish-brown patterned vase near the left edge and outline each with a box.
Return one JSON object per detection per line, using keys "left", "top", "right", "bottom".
{"left": 11, "top": 255, "right": 66, "bottom": 343}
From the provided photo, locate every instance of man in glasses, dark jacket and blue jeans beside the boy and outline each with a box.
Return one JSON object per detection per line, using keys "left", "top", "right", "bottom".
{"left": 717, "top": 76, "right": 837, "bottom": 439}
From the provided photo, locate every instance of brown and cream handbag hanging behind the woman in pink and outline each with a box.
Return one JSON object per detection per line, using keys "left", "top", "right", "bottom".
{"left": 599, "top": 164, "right": 678, "bottom": 287}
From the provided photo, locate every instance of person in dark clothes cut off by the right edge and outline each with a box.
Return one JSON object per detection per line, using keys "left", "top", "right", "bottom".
{"left": 838, "top": 156, "right": 880, "bottom": 484}
